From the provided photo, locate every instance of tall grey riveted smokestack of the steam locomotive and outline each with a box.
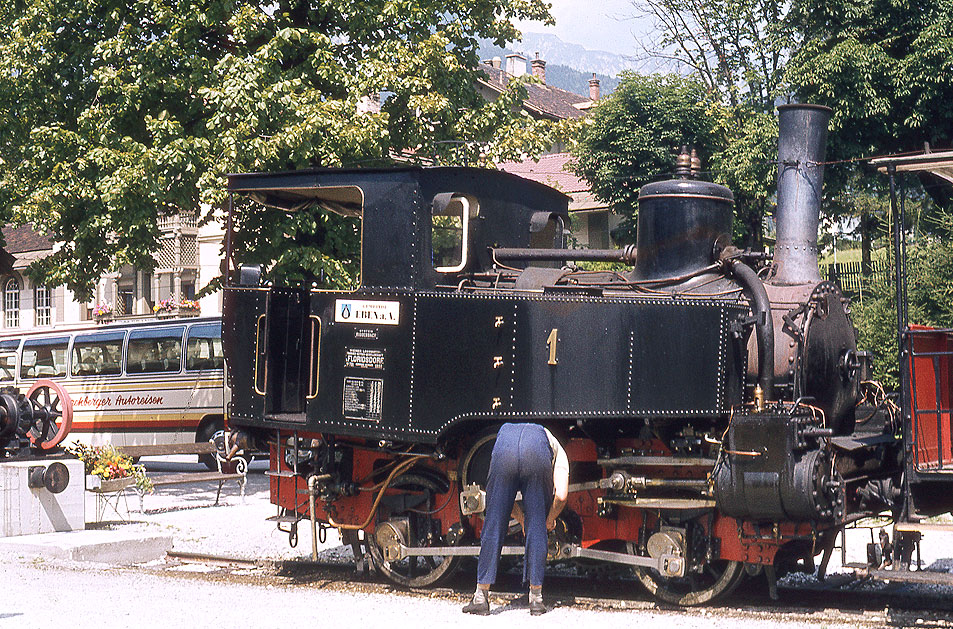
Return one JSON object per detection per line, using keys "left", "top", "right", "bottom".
{"left": 773, "top": 105, "right": 831, "bottom": 285}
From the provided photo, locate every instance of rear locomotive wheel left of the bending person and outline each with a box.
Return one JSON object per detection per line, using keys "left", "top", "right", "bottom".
{"left": 367, "top": 472, "right": 460, "bottom": 588}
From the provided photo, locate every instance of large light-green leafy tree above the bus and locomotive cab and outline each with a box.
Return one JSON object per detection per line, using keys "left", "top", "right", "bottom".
{"left": 0, "top": 0, "right": 549, "bottom": 298}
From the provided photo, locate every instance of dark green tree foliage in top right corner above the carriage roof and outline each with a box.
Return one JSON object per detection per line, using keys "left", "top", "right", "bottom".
{"left": 788, "top": 0, "right": 953, "bottom": 159}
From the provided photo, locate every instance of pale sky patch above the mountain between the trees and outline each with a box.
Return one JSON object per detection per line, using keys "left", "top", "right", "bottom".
{"left": 517, "top": 0, "right": 647, "bottom": 54}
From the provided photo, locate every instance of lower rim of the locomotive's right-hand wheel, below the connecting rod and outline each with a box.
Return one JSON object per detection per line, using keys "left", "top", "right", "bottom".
{"left": 635, "top": 561, "right": 745, "bottom": 607}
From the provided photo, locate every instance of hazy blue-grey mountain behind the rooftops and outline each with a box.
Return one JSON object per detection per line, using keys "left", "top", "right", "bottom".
{"left": 480, "top": 33, "right": 643, "bottom": 96}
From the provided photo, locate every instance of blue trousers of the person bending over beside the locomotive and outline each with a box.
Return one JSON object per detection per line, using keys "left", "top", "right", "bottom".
{"left": 477, "top": 424, "right": 553, "bottom": 586}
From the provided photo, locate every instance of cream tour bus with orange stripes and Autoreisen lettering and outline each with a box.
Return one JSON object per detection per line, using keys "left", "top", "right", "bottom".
{"left": 0, "top": 317, "right": 225, "bottom": 467}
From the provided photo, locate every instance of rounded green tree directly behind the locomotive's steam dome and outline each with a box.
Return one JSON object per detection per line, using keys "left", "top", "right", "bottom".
{"left": 574, "top": 74, "right": 777, "bottom": 247}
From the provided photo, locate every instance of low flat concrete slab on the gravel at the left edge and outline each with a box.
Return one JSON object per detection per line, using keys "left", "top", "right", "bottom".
{"left": 0, "top": 530, "right": 172, "bottom": 565}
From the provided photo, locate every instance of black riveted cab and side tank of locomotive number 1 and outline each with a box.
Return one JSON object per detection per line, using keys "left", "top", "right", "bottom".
{"left": 225, "top": 168, "right": 746, "bottom": 444}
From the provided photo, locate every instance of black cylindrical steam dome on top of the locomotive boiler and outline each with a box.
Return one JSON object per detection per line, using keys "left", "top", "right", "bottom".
{"left": 634, "top": 174, "right": 734, "bottom": 280}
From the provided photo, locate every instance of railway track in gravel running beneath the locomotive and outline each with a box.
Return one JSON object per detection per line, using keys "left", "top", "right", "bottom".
{"left": 158, "top": 552, "right": 953, "bottom": 629}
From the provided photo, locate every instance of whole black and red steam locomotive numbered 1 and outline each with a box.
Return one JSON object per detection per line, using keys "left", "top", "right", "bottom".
{"left": 223, "top": 105, "right": 924, "bottom": 605}
